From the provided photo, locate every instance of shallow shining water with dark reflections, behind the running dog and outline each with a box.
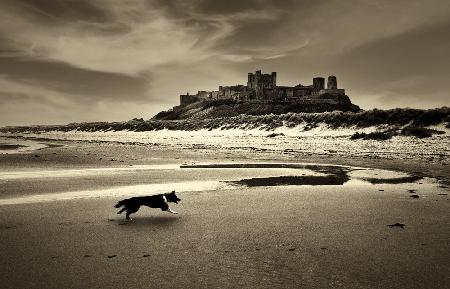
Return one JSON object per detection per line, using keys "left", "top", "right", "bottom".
{"left": 0, "top": 163, "right": 437, "bottom": 205}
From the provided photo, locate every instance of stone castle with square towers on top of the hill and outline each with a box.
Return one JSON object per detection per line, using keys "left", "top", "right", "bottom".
{"left": 180, "top": 70, "right": 345, "bottom": 106}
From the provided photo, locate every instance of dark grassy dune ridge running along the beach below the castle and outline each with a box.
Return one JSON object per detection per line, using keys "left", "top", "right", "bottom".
{"left": 0, "top": 106, "right": 450, "bottom": 133}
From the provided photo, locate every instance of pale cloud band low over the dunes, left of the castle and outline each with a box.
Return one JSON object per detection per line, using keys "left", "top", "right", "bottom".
{"left": 0, "top": 76, "right": 162, "bottom": 125}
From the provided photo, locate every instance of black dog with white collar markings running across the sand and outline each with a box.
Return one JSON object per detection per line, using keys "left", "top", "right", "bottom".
{"left": 114, "top": 191, "right": 181, "bottom": 220}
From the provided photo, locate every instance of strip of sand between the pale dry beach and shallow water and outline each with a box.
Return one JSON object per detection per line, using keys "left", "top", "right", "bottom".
{"left": 0, "top": 136, "right": 450, "bottom": 186}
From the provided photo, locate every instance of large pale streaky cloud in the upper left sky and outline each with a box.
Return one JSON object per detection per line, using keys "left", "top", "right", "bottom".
{"left": 1, "top": 2, "right": 197, "bottom": 75}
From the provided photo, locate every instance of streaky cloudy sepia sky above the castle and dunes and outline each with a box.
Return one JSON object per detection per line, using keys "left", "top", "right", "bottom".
{"left": 0, "top": 0, "right": 450, "bottom": 126}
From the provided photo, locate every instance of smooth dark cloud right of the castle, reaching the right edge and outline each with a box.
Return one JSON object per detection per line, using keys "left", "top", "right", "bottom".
{"left": 338, "top": 23, "right": 450, "bottom": 81}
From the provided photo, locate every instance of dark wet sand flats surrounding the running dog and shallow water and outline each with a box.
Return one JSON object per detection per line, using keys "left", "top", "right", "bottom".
{"left": 0, "top": 142, "right": 450, "bottom": 288}
